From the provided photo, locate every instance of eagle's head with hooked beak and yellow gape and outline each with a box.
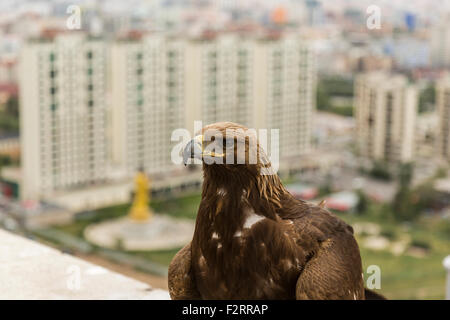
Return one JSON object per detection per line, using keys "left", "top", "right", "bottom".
{"left": 183, "top": 122, "right": 271, "bottom": 184}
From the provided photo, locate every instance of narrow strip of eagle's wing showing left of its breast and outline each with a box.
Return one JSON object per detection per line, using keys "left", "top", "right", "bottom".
{"left": 168, "top": 243, "right": 201, "bottom": 300}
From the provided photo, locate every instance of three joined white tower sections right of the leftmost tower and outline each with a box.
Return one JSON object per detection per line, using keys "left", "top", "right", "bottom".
{"left": 112, "top": 34, "right": 315, "bottom": 174}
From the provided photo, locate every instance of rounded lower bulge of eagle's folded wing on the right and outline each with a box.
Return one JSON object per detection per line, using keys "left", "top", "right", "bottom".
{"left": 296, "top": 233, "right": 364, "bottom": 300}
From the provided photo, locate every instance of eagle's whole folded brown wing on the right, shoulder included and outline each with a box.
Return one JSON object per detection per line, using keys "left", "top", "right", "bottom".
{"left": 284, "top": 202, "right": 364, "bottom": 300}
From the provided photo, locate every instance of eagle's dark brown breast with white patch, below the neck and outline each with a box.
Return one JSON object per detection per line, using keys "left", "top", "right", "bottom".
{"left": 193, "top": 195, "right": 302, "bottom": 299}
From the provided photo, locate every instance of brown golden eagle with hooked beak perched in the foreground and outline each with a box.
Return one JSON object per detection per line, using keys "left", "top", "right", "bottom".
{"left": 168, "top": 122, "right": 382, "bottom": 299}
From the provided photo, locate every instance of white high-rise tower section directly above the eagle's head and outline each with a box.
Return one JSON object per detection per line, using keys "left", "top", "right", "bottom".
{"left": 186, "top": 35, "right": 257, "bottom": 126}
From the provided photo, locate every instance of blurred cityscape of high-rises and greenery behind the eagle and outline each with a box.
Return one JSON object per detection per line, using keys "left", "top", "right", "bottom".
{"left": 0, "top": 0, "right": 450, "bottom": 299}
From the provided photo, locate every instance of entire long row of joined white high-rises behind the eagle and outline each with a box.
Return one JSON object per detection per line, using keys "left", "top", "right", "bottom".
{"left": 20, "top": 33, "right": 316, "bottom": 204}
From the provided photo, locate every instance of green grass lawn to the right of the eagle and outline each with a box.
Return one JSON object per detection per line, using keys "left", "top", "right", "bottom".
{"left": 339, "top": 214, "right": 450, "bottom": 299}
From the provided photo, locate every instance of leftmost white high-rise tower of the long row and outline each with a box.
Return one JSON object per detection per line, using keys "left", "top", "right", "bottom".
{"left": 19, "top": 34, "right": 108, "bottom": 199}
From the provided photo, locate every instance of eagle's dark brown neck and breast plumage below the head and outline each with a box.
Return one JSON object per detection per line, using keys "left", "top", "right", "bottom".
{"left": 191, "top": 173, "right": 301, "bottom": 299}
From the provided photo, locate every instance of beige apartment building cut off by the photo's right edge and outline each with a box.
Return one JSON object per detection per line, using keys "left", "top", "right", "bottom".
{"left": 436, "top": 78, "right": 450, "bottom": 160}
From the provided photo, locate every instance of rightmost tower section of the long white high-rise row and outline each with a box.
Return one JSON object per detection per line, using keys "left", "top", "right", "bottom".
{"left": 252, "top": 36, "right": 316, "bottom": 160}
